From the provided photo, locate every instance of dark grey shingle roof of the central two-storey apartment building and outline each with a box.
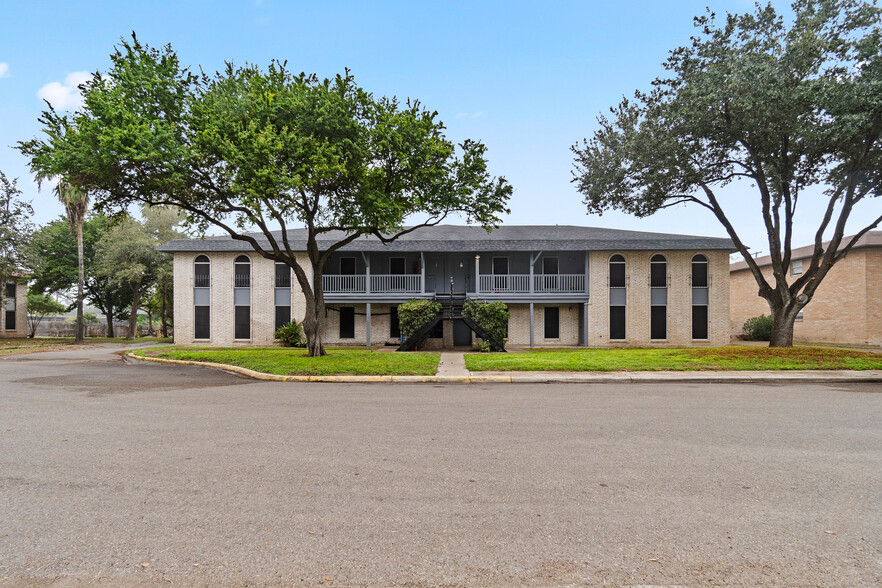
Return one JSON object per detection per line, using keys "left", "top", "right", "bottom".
{"left": 159, "top": 225, "right": 735, "bottom": 253}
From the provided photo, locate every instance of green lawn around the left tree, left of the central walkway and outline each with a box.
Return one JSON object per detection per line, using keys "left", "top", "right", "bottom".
{"left": 138, "top": 347, "right": 441, "bottom": 376}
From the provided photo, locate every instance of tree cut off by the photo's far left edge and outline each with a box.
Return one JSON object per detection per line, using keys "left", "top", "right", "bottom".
{"left": 0, "top": 171, "right": 34, "bottom": 286}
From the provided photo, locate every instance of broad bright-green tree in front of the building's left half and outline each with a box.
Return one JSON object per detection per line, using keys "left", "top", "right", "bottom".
{"left": 21, "top": 36, "right": 511, "bottom": 355}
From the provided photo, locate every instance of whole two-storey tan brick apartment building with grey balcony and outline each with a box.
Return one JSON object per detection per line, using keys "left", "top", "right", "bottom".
{"left": 159, "top": 225, "right": 734, "bottom": 347}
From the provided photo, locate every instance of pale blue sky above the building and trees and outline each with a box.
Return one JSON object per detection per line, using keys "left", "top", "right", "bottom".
{"left": 0, "top": 0, "right": 878, "bottom": 253}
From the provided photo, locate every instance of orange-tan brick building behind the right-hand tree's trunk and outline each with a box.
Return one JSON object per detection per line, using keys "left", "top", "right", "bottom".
{"left": 730, "top": 231, "right": 882, "bottom": 345}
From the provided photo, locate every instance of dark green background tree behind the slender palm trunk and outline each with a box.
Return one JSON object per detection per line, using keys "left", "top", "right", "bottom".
{"left": 28, "top": 213, "right": 132, "bottom": 337}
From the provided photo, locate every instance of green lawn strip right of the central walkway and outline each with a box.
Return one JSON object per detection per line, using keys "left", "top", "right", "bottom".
{"left": 465, "top": 346, "right": 882, "bottom": 372}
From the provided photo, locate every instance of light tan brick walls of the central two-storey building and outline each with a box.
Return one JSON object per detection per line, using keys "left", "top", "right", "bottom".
{"left": 174, "top": 250, "right": 729, "bottom": 348}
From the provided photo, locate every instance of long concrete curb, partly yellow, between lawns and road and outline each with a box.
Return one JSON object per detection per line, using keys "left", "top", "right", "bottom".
{"left": 124, "top": 350, "right": 882, "bottom": 384}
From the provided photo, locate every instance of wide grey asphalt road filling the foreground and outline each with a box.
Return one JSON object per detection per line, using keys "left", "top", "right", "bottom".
{"left": 0, "top": 348, "right": 882, "bottom": 587}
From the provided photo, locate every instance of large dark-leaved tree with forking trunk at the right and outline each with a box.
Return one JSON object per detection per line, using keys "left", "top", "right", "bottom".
{"left": 573, "top": 0, "right": 882, "bottom": 346}
